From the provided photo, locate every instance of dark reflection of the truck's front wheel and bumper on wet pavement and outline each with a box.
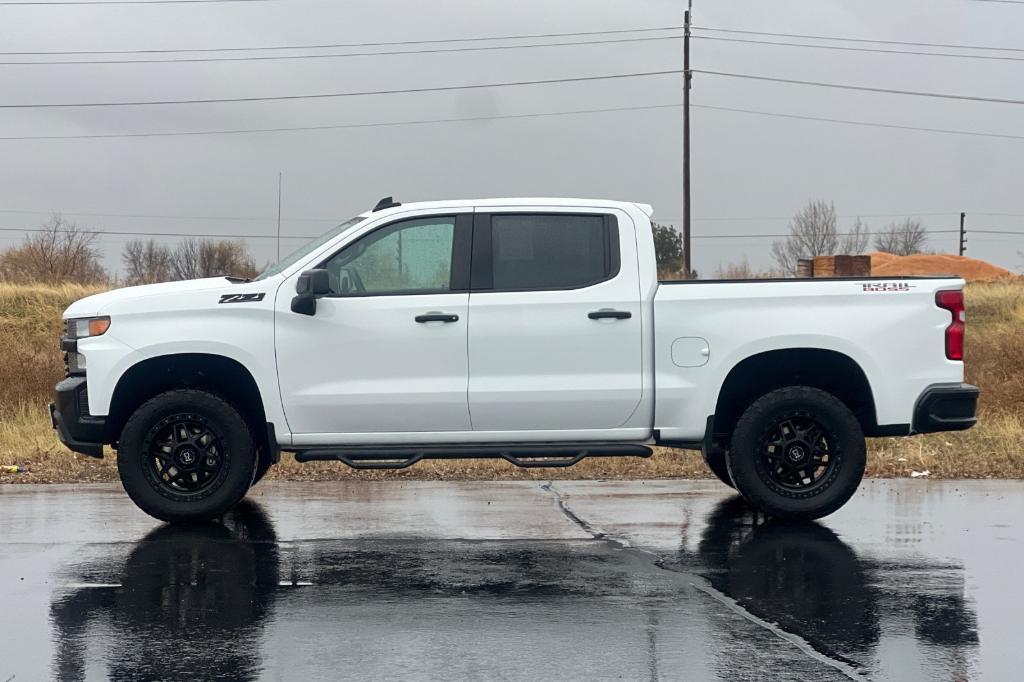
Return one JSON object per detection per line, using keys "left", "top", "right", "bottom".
{"left": 51, "top": 501, "right": 281, "bottom": 680}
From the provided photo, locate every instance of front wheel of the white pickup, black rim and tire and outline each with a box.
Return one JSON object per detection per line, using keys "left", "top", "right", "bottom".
{"left": 118, "top": 390, "right": 256, "bottom": 521}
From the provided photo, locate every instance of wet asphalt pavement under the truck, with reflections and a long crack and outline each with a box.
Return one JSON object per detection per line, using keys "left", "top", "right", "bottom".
{"left": 0, "top": 480, "right": 1024, "bottom": 682}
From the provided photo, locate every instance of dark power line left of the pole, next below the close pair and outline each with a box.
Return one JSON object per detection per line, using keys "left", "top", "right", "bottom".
{"left": 0, "top": 69, "right": 683, "bottom": 109}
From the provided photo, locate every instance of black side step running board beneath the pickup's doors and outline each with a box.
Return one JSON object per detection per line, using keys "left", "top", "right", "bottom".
{"left": 295, "top": 442, "right": 651, "bottom": 469}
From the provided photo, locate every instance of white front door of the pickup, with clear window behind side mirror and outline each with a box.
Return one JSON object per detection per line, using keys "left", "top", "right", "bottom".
{"left": 275, "top": 213, "right": 472, "bottom": 444}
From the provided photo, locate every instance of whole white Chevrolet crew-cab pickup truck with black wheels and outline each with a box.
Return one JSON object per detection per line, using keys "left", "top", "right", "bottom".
{"left": 50, "top": 198, "right": 978, "bottom": 521}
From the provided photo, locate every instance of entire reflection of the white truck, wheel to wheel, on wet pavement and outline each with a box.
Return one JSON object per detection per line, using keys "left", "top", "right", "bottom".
{"left": 51, "top": 489, "right": 978, "bottom": 680}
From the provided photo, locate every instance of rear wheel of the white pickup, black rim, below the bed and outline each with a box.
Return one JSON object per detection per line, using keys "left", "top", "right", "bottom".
{"left": 727, "top": 386, "right": 866, "bottom": 519}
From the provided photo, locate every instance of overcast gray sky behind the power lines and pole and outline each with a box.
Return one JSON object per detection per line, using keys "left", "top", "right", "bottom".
{"left": 0, "top": 0, "right": 1024, "bottom": 274}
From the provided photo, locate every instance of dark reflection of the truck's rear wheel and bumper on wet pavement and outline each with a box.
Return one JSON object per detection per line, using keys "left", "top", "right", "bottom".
{"left": 667, "top": 497, "right": 978, "bottom": 679}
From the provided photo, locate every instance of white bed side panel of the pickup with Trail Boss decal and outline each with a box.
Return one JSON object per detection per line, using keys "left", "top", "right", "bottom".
{"left": 653, "top": 276, "right": 964, "bottom": 440}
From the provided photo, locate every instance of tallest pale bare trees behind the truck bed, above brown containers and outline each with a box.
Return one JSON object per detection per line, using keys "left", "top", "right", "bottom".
{"left": 771, "top": 201, "right": 870, "bottom": 274}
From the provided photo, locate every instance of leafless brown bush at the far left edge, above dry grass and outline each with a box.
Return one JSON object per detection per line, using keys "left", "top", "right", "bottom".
{"left": 0, "top": 214, "right": 108, "bottom": 284}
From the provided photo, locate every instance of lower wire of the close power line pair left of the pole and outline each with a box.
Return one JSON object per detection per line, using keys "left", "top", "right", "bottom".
{"left": 0, "top": 36, "right": 684, "bottom": 67}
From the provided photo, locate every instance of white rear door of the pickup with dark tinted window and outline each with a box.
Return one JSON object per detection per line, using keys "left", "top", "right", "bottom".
{"left": 469, "top": 209, "right": 642, "bottom": 430}
